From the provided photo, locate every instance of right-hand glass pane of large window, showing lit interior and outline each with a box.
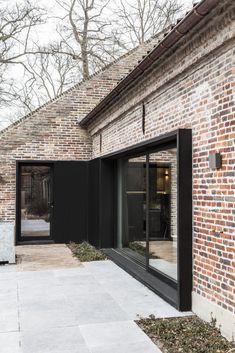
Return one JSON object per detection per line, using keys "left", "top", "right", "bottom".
{"left": 149, "top": 148, "right": 177, "bottom": 279}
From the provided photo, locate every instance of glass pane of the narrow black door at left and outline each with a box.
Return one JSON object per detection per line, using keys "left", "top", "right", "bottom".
{"left": 21, "top": 166, "right": 51, "bottom": 237}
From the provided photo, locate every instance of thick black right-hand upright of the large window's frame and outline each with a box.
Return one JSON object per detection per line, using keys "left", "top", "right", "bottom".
{"left": 177, "top": 129, "right": 192, "bottom": 311}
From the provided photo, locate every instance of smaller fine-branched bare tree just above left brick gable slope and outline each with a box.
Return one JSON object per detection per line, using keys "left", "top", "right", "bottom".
{"left": 5, "top": 48, "right": 81, "bottom": 116}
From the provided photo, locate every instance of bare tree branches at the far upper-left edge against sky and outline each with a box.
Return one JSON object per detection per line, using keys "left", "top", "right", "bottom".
{"left": 0, "top": 0, "right": 48, "bottom": 129}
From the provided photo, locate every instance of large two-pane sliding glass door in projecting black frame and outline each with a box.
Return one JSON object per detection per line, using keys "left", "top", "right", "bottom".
{"left": 114, "top": 129, "right": 192, "bottom": 311}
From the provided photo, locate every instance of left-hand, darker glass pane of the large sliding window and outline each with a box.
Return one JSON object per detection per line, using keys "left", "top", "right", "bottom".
{"left": 118, "top": 156, "right": 146, "bottom": 263}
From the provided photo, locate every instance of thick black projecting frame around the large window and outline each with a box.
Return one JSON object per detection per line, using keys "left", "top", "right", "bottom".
{"left": 101, "top": 129, "right": 192, "bottom": 311}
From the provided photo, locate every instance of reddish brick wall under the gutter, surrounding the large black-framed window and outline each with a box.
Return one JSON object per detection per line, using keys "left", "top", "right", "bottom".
{"left": 88, "top": 1, "right": 235, "bottom": 312}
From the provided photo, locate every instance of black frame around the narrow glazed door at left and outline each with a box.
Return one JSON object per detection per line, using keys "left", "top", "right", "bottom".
{"left": 16, "top": 160, "right": 54, "bottom": 244}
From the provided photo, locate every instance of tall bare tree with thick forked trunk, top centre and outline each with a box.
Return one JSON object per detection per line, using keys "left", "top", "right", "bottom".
{"left": 53, "top": 0, "right": 120, "bottom": 79}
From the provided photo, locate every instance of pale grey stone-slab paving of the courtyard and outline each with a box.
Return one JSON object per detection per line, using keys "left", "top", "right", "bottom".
{"left": 0, "top": 245, "right": 191, "bottom": 353}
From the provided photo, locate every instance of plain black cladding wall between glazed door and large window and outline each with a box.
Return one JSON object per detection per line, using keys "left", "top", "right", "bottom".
{"left": 52, "top": 159, "right": 115, "bottom": 247}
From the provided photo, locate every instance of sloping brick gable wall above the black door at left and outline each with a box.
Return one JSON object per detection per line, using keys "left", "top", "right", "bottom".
{"left": 0, "top": 32, "right": 164, "bottom": 221}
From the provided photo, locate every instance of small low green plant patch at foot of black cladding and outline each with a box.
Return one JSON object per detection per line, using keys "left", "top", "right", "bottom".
{"left": 68, "top": 241, "right": 107, "bottom": 262}
